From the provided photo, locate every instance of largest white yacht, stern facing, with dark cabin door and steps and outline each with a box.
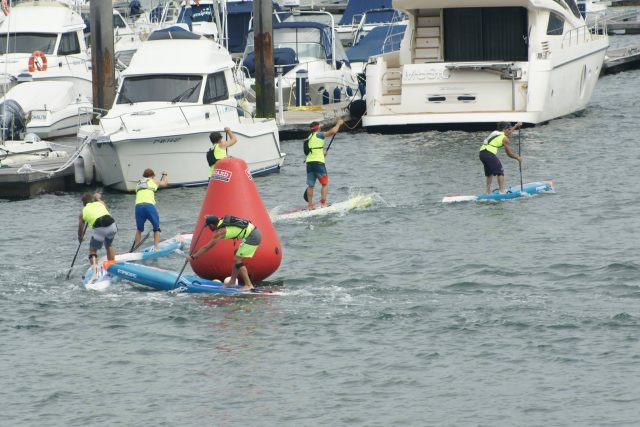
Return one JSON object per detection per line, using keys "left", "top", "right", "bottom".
{"left": 363, "top": 0, "right": 609, "bottom": 131}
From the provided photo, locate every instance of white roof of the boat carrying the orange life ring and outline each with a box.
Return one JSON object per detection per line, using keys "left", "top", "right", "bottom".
{"left": 0, "top": 2, "right": 85, "bottom": 34}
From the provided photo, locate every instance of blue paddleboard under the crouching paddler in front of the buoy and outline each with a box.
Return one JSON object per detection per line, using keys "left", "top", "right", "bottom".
{"left": 108, "top": 262, "right": 275, "bottom": 295}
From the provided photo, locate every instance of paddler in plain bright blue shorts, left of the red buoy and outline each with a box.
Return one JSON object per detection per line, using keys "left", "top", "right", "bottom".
{"left": 133, "top": 168, "right": 169, "bottom": 251}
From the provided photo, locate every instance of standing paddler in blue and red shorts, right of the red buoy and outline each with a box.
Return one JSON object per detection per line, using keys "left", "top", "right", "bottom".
{"left": 305, "top": 119, "right": 344, "bottom": 209}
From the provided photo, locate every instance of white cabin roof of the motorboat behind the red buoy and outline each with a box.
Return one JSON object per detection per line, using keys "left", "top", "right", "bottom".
{"left": 121, "top": 37, "right": 234, "bottom": 77}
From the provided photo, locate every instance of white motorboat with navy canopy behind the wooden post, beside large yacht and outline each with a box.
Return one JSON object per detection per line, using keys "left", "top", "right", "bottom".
{"left": 242, "top": 12, "right": 358, "bottom": 109}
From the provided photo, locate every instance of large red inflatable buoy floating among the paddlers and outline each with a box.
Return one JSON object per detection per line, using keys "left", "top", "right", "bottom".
{"left": 191, "top": 158, "right": 282, "bottom": 282}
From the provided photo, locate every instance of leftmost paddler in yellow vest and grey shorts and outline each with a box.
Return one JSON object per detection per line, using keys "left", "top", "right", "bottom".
{"left": 78, "top": 193, "right": 118, "bottom": 277}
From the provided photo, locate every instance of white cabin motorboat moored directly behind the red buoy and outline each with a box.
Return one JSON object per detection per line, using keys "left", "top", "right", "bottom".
{"left": 80, "top": 27, "right": 284, "bottom": 191}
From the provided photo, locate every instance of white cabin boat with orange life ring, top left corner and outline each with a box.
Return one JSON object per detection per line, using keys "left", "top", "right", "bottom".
{"left": 0, "top": 0, "right": 93, "bottom": 97}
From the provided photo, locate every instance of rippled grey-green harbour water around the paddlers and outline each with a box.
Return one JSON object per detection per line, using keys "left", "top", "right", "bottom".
{"left": 0, "top": 39, "right": 640, "bottom": 426}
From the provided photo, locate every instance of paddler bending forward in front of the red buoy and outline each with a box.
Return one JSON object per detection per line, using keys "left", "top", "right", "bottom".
{"left": 187, "top": 215, "right": 262, "bottom": 291}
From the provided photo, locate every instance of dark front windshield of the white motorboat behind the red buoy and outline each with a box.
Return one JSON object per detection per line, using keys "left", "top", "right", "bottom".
{"left": 116, "top": 75, "right": 202, "bottom": 104}
